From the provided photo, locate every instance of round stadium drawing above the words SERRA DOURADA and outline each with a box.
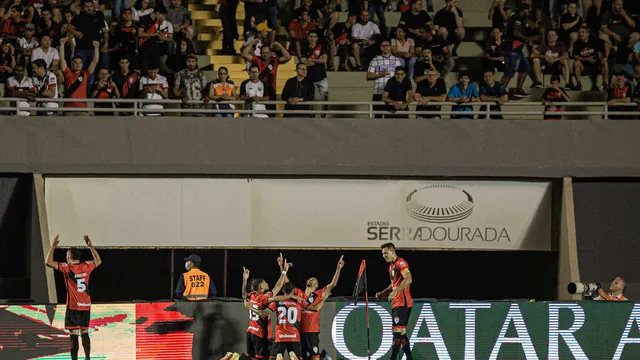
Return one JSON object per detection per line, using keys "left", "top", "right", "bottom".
{"left": 405, "top": 185, "right": 474, "bottom": 224}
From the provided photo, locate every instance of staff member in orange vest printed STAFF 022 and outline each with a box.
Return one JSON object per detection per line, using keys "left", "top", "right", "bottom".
{"left": 176, "top": 254, "right": 216, "bottom": 301}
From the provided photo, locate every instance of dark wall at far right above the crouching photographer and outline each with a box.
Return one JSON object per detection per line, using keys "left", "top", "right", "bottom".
{"left": 573, "top": 180, "right": 640, "bottom": 299}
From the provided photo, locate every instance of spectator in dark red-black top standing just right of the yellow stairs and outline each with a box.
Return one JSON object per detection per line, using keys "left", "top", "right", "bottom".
{"left": 303, "top": 30, "right": 329, "bottom": 101}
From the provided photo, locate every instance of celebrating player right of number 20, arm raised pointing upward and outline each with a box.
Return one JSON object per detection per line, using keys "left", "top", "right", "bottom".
{"left": 279, "top": 254, "right": 344, "bottom": 360}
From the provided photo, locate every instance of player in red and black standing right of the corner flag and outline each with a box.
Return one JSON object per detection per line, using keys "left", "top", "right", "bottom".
{"left": 376, "top": 243, "right": 413, "bottom": 360}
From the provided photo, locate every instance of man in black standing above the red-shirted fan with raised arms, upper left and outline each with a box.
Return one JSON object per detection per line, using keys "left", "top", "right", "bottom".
{"left": 68, "top": 0, "right": 109, "bottom": 71}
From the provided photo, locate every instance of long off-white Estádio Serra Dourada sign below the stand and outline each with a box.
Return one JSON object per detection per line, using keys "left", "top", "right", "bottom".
{"left": 46, "top": 178, "right": 551, "bottom": 250}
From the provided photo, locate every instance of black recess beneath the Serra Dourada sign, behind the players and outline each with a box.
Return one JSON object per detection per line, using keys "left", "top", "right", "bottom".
{"left": 56, "top": 250, "right": 557, "bottom": 302}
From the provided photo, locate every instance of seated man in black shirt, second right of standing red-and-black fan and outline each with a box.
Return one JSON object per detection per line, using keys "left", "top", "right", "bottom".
{"left": 573, "top": 26, "right": 609, "bottom": 91}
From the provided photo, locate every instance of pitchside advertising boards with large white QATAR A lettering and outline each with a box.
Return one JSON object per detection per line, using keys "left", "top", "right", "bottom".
{"left": 0, "top": 300, "right": 640, "bottom": 360}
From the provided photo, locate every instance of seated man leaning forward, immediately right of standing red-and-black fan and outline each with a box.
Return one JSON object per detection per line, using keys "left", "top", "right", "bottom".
{"left": 531, "top": 29, "right": 571, "bottom": 90}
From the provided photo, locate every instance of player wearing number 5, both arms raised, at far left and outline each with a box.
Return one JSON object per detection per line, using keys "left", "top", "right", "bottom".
{"left": 46, "top": 235, "right": 102, "bottom": 360}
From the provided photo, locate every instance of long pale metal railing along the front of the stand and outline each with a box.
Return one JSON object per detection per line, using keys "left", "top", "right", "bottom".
{"left": 0, "top": 98, "right": 640, "bottom": 119}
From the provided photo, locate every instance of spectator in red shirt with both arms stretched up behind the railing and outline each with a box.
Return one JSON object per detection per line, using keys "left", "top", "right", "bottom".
{"left": 60, "top": 41, "right": 100, "bottom": 116}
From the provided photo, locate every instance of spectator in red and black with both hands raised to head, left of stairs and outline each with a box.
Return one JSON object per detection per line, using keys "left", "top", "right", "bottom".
{"left": 242, "top": 39, "right": 291, "bottom": 105}
